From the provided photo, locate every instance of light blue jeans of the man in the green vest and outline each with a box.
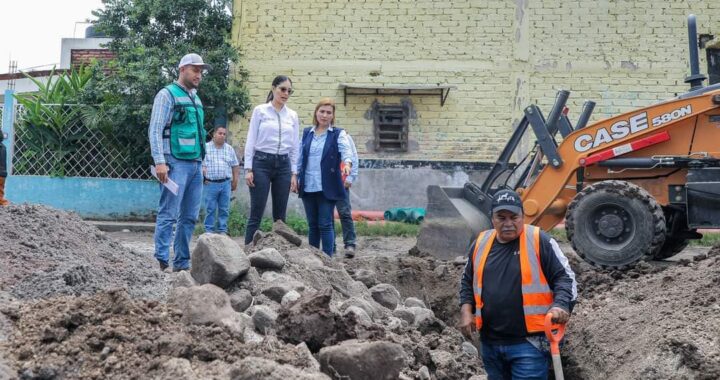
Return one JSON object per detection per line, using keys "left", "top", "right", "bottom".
{"left": 155, "top": 155, "right": 203, "bottom": 270}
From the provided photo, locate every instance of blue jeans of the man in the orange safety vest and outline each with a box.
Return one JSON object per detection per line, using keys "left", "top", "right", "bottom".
{"left": 482, "top": 342, "right": 550, "bottom": 380}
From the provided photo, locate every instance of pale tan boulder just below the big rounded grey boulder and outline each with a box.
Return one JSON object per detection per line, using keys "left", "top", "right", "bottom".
{"left": 169, "top": 284, "right": 248, "bottom": 334}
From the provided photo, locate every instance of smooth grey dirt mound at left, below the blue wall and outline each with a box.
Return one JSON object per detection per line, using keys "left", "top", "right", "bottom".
{"left": 0, "top": 205, "right": 167, "bottom": 299}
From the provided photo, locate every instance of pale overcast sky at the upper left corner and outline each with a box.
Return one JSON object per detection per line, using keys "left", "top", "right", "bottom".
{"left": 0, "top": 0, "right": 102, "bottom": 73}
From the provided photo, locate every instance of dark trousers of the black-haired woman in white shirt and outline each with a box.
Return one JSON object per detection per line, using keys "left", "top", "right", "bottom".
{"left": 245, "top": 152, "right": 292, "bottom": 244}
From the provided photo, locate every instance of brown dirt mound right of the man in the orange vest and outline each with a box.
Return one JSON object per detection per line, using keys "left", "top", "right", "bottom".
{"left": 563, "top": 247, "right": 720, "bottom": 379}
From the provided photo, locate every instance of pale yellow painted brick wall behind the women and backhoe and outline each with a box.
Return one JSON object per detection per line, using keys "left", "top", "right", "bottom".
{"left": 231, "top": 0, "right": 720, "bottom": 162}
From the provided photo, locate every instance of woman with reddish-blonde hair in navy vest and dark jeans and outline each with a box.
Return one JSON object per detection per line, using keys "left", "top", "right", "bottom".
{"left": 297, "top": 98, "right": 352, "bottom": 256}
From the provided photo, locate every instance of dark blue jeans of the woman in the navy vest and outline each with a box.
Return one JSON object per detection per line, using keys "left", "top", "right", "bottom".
{"left": 302, "top": 191, "right": 335, "bottom": 256}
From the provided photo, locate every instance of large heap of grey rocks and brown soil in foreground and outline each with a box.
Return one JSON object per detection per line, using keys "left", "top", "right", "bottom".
{"left": 0, "top": 220, "right": 482, "bottom": 380}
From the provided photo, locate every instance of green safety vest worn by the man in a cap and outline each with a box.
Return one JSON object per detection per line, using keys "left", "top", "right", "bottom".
{"left": 163, "top": 83, "right": 206, "bottom": 160}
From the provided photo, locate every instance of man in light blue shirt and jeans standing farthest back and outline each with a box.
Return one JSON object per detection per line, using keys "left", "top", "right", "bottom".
{"left": 203, "top": 126, "right": 240, "bottom": 235}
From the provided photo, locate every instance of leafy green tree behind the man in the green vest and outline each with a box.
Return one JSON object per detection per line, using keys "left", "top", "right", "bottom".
{"left": 84, "top": 0, "right": 250, "bottom": 168}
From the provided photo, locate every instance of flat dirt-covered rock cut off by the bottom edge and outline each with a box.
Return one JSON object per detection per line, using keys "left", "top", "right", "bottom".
{"left": 228, "top": 356, "right": 330, "bottom": 380}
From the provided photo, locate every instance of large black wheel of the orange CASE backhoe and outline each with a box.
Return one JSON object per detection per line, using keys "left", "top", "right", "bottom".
{"left": 565, "top": 181, "right": 666, "bottom": 270}
